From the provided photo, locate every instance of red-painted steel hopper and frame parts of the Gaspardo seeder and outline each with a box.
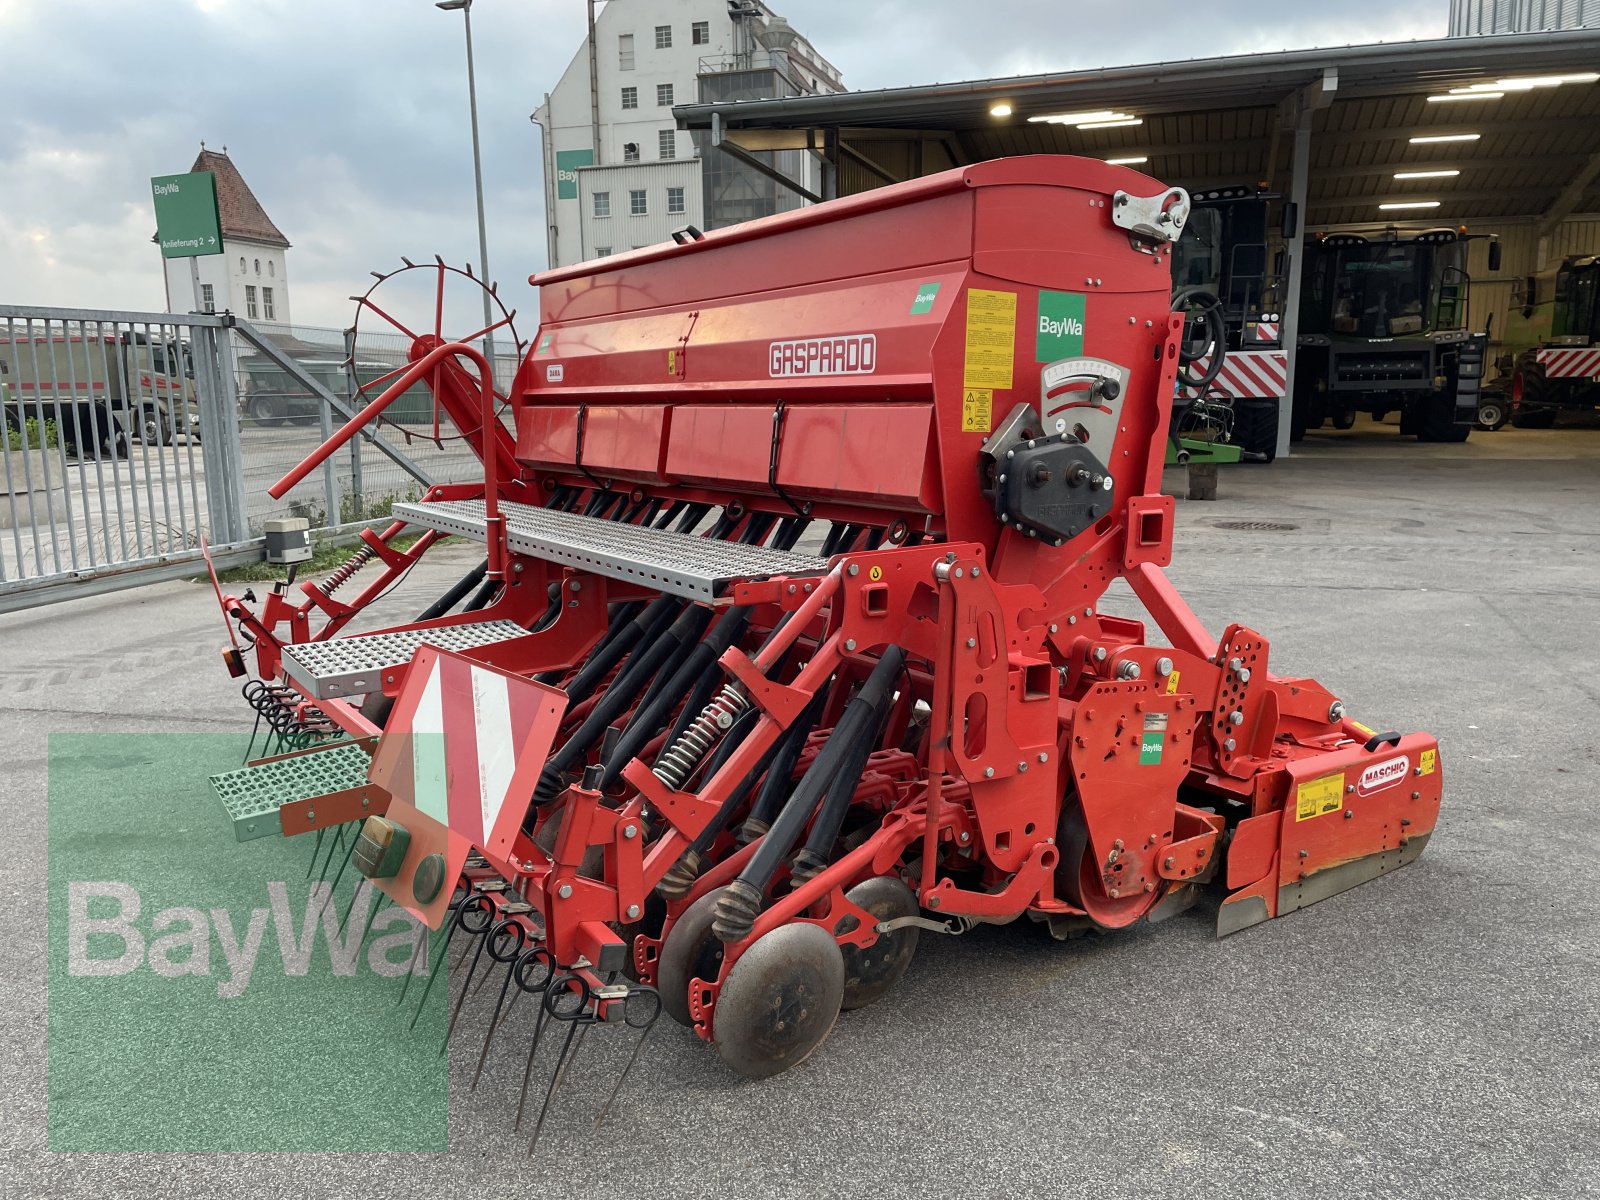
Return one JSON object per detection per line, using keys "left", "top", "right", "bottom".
{"left": 224, "top": 157, "right": 1442, "bottom": 1037}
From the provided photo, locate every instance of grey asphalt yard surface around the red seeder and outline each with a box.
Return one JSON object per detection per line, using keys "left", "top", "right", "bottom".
{"left": 0, "top": 424, "right": 1600, "bottom": 1200}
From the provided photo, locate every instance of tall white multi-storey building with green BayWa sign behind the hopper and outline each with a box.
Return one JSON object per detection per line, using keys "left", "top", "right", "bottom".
{"left": 533, "top": 0, "right": 845, "bottom": 266}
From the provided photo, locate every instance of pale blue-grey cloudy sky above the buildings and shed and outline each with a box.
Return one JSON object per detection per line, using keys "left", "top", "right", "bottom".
{"left": 0, "top": 0, "right": 1448, "bottom": 336}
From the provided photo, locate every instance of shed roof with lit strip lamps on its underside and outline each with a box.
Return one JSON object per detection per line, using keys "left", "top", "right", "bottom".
{"left": 675, "top": 30, "right": 1600, "bottom": 226}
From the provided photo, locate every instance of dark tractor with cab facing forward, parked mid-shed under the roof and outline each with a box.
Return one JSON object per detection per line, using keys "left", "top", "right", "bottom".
{"left": 1290, "top": 229, "right": 1499, "bottom": 442}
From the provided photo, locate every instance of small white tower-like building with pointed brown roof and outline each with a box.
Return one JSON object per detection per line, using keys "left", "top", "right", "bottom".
{"left": 162, "top": 147, "right": 290, "bottom": 325}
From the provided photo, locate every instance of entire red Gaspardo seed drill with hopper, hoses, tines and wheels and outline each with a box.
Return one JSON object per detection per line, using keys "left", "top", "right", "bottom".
{"left": 206, "top": 157, "right": 1442, "bottom": 1125}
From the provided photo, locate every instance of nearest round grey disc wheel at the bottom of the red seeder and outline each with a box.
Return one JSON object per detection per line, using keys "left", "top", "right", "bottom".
{"left": 712, "top": 922, "right": 845, "bottom": 1078}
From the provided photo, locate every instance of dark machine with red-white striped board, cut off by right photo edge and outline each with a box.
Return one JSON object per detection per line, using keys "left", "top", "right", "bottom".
{"left": 1478, "top": 254, "right": 1600, "bottom": 429}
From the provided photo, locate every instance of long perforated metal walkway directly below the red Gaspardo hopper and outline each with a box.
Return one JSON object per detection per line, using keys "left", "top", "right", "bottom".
{"left": 394, "top": 499, "right": 827, "bottom": 600}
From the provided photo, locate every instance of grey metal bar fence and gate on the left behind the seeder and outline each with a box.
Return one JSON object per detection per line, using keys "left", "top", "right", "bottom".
{"left": 0, "top": 306, "right": 515, "bottom": 611}
